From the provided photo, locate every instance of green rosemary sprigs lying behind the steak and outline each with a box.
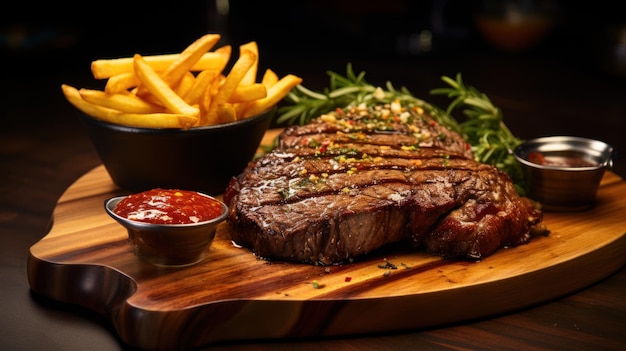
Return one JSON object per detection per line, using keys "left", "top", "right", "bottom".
{"left": 276, "top": 64, "right": 526, "bottom": 194}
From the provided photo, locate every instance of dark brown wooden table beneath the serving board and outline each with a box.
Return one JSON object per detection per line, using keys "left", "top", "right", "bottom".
{"left": 0, "top": 33, "right": 626, "bottom": 351}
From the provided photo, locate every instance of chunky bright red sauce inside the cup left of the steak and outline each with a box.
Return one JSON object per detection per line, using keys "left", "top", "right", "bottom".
{"left": 114, "top": 189, "right": 222, "bottom": 224}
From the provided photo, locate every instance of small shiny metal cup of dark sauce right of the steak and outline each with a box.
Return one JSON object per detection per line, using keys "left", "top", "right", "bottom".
{"left": 513, "top": 136, "right": 613, "bottom": 211}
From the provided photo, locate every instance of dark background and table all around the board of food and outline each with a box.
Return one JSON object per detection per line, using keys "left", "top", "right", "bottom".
{"left": 0, "top": 0, "right": 626, "bottom": 350}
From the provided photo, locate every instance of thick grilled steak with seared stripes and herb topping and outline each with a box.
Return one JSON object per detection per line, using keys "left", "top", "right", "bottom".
{"left": 224, "top": 104, "right": 542, "bottom": 265}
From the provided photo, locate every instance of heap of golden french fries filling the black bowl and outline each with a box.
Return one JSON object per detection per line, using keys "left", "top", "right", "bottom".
{"left": 61, "top": 34, "right": 302, "bottom": 129}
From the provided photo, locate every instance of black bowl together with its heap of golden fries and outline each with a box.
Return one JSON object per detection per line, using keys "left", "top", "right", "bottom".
{"left": 61, "top": 34, "right": 302, "bottom": 194}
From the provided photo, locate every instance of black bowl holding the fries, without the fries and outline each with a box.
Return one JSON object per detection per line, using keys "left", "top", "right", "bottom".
{"left": 82, "top": 108, "right": 276, "bottom": 195}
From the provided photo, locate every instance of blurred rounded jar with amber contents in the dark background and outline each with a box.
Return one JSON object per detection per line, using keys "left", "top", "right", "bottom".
{"left": 474, "top": 0, "right": 556, "bottom": 52}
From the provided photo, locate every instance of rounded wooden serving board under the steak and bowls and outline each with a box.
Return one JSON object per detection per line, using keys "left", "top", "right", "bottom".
{"left": 28, "top": 133, "right": 626, "bottom": 350}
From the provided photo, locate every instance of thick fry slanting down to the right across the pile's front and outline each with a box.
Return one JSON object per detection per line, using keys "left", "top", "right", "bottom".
{"left": 133, "top": 54, "right": 200, "bottom": 117}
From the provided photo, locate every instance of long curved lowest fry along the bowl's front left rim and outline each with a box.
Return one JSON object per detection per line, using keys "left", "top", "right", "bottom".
{"left": 61, "top": 84, "right": 198, "bottom": 129}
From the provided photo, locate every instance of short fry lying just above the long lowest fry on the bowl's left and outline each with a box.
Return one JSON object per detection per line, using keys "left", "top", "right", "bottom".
{"left": 78, "top": 88, "right": 164, "bottom": 113}
